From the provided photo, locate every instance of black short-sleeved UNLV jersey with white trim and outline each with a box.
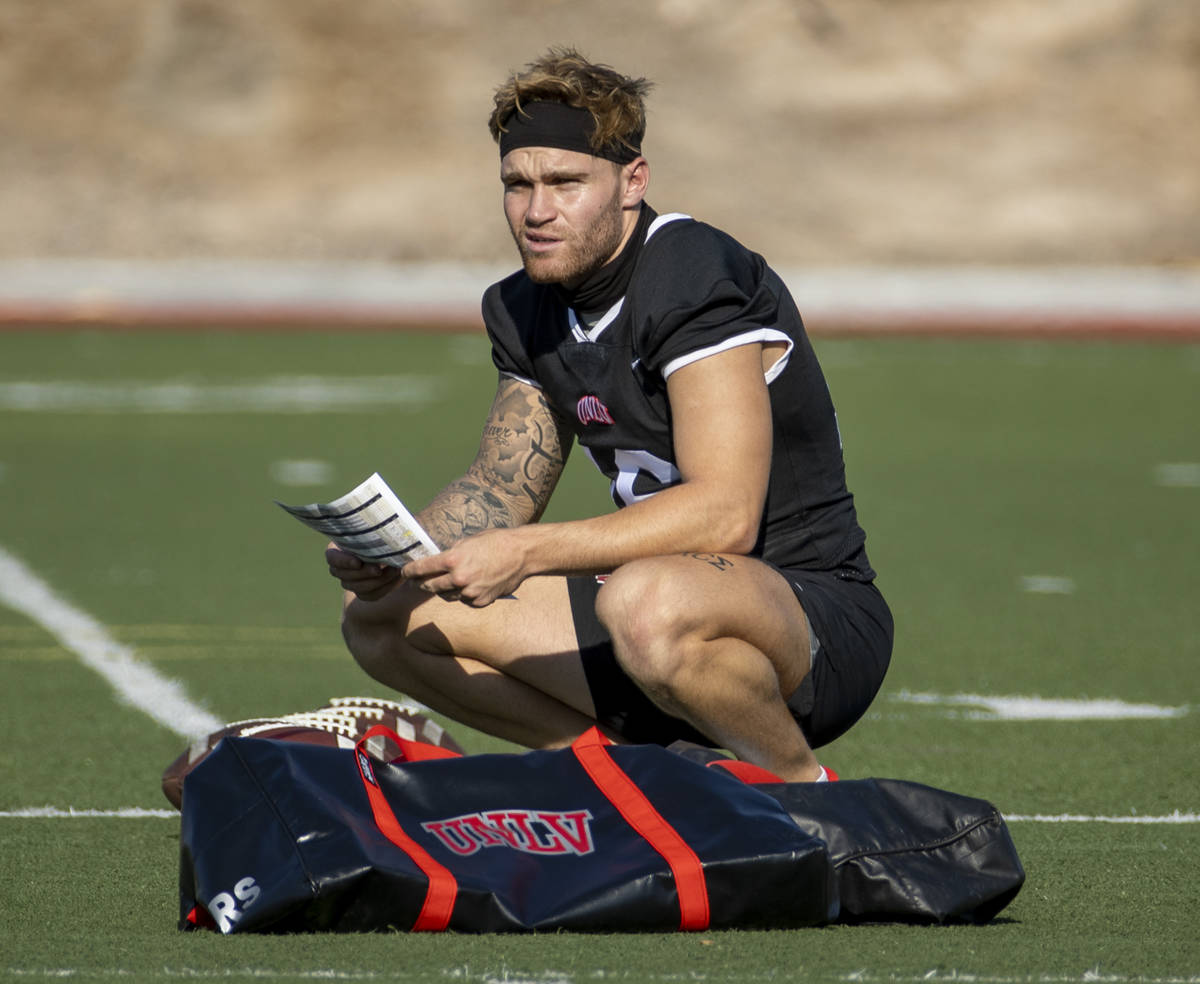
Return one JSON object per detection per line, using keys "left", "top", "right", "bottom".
{"left": 484, "top": 205, "right": 874, "bottom": 581}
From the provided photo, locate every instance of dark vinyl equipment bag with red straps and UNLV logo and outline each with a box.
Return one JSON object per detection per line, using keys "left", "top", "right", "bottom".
{"left": 180, "top": 727, "right": 838, "bottom": 932}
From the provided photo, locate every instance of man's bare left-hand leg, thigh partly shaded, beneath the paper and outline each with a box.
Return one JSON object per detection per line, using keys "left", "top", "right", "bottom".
{"left": 342, "top": 577, "right": 609, "bottom": 748}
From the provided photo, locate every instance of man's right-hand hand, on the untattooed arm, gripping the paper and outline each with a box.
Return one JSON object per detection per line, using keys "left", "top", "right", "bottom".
{"left": 401, "top": 527, "right": 528, "bottom": 608}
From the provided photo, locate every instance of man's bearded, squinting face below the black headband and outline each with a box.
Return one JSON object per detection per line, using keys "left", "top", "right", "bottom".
{"left": 500, "top": 146, "right": 640, "bottom": 287}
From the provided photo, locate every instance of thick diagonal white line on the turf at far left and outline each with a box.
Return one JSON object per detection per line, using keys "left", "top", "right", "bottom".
{"left": 0, "top": 547, "right": 223, "bottom": 738}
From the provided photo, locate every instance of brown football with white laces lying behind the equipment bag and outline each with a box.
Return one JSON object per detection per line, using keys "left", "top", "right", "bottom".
{"left": 162, "top": 697, "right": 462, "bottom": 810}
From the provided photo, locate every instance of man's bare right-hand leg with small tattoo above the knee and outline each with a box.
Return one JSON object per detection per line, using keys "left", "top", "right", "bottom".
{"left": 596, "top": 554, "right": 821, "bottom": 781}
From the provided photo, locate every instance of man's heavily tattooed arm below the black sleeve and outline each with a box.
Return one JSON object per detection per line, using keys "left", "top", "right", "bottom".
{"left": 418, "top": 377, "right": 571, "bottom": 548}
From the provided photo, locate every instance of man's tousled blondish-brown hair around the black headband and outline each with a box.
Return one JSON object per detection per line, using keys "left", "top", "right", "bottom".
{"left": 487, "top": 48, "right": 653, "bottom": 154}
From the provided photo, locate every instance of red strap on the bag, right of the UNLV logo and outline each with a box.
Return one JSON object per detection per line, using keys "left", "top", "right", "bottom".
{"left": 571, "top": 727, "right": 710, "bottom": 930}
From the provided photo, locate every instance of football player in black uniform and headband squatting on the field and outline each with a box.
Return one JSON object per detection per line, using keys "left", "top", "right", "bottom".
{"left": 326, "top": 48, "right": 893, "bottom": 781}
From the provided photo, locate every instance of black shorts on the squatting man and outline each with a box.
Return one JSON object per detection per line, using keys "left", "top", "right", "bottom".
{"left": 566, "top": 568, "right": 893, "bottom": 748}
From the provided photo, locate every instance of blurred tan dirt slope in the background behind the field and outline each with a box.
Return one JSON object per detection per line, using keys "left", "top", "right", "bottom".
{"left": 0, "top": 0, "right": 1200, "bottom": 266}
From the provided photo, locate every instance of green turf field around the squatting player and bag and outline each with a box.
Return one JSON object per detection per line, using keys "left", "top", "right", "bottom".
{"left": 0, "top": 331, "right": 1200, "bottom": 984}
